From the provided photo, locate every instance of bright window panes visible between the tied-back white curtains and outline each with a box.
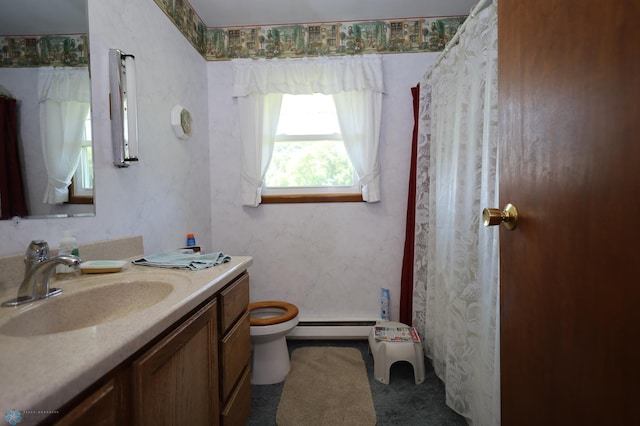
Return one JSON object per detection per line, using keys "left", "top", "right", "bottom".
{"left": 262, "top": 93, "right": 360, "bottom": 202}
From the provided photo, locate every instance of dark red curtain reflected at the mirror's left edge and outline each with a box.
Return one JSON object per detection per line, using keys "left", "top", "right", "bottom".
{"left": 0, "top": 96, "right": 27, "bottom": 219}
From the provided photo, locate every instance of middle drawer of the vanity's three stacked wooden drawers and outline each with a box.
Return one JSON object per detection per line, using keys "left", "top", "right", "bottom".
{"left": 221, "top": 312, "right": 251, "bottom": 402}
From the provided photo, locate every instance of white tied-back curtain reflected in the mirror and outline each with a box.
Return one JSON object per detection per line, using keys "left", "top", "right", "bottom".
{"left": 38, "top": 68, "right": 91, "bottom": 204}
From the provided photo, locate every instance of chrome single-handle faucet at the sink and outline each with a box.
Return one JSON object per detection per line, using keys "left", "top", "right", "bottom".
{"left": 1, "top": 240, "right": 81, "bottom": 306}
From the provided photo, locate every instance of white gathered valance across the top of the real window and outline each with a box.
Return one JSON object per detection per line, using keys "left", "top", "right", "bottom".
{"left": 232, "top": 55, "right": 384, "bottom": 97}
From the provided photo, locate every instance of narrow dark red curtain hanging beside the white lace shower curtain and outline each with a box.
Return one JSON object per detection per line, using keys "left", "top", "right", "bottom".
{"left": 400, "top": 84, "right": 420, "bottom": 325}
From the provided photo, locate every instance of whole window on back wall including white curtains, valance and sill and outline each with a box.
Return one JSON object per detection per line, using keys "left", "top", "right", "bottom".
{"left": 232, "top": 55, "right": 384, "bottom": 207}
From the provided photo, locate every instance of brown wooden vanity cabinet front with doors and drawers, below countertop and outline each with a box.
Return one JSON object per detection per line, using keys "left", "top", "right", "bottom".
{"left": 56, "top": 272, "right": 251, "bottom": 426}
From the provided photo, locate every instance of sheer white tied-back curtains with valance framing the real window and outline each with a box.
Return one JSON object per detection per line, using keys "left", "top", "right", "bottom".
{"left": 232, "top": 55, "right": 384, "bottom": 207}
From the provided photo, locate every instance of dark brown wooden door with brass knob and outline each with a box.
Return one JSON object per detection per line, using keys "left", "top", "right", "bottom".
{"left": 498, "top": 0, "right": 640, "bottom": 426}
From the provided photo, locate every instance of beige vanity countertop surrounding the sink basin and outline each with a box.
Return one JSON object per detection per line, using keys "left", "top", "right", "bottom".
{"left": 0, "top": 256, "right": 253, "bottom": 413}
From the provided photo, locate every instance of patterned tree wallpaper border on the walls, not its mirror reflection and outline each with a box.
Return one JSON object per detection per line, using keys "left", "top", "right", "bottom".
{"left": 154, "top": 0, "right": 466, "bottom": 61}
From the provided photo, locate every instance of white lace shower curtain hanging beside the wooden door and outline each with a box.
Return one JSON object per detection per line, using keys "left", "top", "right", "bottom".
{"left": 413, "top": 1, "right": 500, "bottom": 426}
